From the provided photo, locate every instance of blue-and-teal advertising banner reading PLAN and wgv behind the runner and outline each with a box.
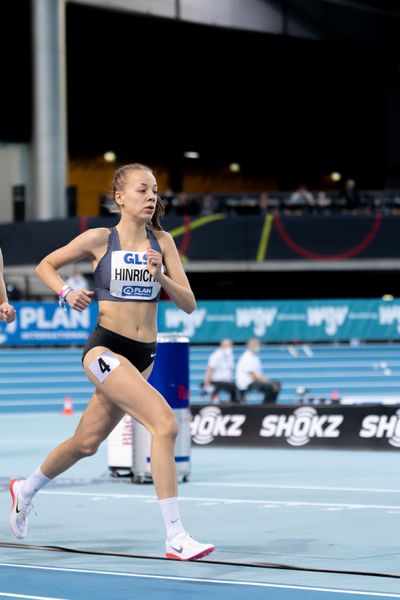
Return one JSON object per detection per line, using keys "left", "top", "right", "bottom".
{"left": 0, "top": 300, "right": 400, "bottom": 346}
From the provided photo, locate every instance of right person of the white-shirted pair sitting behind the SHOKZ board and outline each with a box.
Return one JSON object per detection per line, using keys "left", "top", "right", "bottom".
{"left": 236, "top": 338, "right": 281, "bottom": 404}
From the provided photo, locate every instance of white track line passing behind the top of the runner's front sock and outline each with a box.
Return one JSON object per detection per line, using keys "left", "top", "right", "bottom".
{"left": 41, "top": 490, "right": 400, "bottom": 510}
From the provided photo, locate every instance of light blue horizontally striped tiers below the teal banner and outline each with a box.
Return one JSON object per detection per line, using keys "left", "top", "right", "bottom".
{"left": 0, "top": 344, "right": 400, "bottom": 412}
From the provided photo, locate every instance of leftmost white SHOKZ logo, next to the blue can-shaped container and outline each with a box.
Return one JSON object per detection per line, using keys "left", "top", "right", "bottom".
{"left": 191, "top": 406, "right": 246, "bottom": 445}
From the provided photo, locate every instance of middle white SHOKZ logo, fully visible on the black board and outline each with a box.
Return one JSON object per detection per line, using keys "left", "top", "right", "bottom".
{"left": 260, "top": 406, "right": 344, "bottom": 446}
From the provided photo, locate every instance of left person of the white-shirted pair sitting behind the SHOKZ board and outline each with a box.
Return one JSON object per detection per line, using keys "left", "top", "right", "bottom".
{"left": 203, "top": 339, "right": 237, "bottom": 403}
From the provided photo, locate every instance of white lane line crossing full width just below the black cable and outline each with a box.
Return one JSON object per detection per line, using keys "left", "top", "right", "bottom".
{"left": 0, "top": 563, "right": 400, "bottom": 598}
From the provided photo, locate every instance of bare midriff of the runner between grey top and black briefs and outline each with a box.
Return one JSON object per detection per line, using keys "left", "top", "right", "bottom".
{"left": 98, "top": 300, "right": 157, "bottom": 342}
